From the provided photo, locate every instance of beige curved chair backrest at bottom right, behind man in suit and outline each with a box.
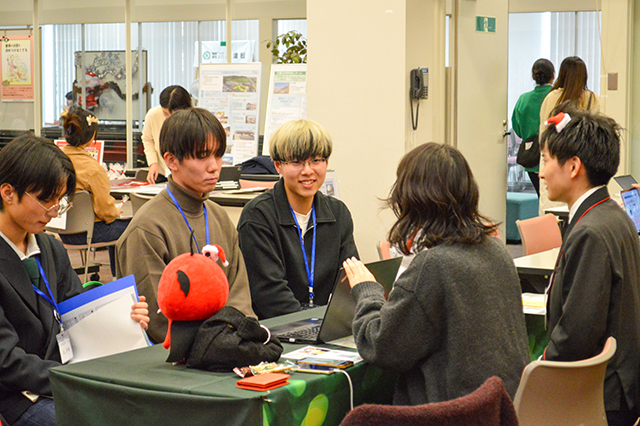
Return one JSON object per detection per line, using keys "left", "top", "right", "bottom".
{"left": 514, "top": 337, "right": 616, "bottom": 426}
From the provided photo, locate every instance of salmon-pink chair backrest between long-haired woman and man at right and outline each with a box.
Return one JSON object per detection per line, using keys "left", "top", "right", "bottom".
{"left": 516, "top": 213, "right": 562, "bottom": 255}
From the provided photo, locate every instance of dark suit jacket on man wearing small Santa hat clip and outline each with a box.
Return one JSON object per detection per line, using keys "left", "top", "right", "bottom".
{"left": 544, "top": 188, "right": 640, "bottom": 411}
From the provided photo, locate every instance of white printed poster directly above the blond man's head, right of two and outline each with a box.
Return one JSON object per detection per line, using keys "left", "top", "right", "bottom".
{"left": 262, "top": 64, "right": 307, "bottom": 155}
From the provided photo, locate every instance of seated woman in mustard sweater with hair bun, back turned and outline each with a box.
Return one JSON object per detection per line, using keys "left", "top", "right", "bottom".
{"left": 60, "top": 107, "right": 129, "bottom": 277}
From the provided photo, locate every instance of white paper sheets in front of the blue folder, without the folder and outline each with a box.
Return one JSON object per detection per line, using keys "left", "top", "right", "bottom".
{"left": 67, "top": 295, "right": 148, "bottom": 363}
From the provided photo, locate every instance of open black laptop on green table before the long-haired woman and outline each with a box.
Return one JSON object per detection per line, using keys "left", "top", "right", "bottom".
{"left": 270, "top": 257, "right": 402, "bottom": 344}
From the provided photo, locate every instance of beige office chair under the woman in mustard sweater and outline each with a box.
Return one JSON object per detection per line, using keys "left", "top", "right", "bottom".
{"left": 47, "top": 191, "right": 116, "bottom": 282}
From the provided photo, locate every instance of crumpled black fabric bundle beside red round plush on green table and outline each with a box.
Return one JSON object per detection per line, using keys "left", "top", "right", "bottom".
{"left": 187, "top": 306, "right": 283, "bottom": 372}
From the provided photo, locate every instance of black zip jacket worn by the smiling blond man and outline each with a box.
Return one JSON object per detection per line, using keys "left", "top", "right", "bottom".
{"left": 238, "top": 179, "right": 358, "bottom": 319}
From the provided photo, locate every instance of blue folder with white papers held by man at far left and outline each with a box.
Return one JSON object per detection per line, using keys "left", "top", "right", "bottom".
{"left": 58, "top": 275, "right": 150, "bottom": 363}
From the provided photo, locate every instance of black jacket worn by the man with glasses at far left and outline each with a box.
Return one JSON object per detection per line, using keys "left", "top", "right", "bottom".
{"left": 0, "top": 233, "right": 82, "bottom": 423}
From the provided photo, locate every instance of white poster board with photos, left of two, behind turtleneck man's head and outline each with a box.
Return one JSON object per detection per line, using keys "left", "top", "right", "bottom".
{"left": 198, "top": 62, "right": 262, "bottom": 165}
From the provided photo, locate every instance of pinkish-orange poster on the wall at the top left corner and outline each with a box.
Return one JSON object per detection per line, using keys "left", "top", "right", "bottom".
{"left": 0, "top": 36, "right": 33, "bottom": 101}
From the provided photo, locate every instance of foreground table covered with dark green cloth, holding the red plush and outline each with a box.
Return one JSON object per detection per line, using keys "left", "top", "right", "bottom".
{"left": 50, "top": 307, "right": 395, "bottom": 426}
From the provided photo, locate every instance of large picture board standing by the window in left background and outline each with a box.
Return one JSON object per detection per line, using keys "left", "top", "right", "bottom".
{"left": 73, "top": 50, "right": 149, "bottom": 121}
